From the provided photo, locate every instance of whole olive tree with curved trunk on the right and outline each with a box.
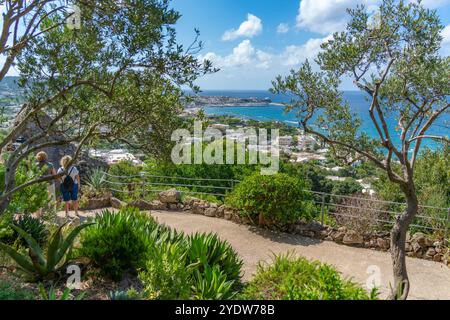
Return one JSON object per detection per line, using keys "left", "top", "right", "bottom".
{"left": 273, "top": 0, "right": 450, "bottom": 299}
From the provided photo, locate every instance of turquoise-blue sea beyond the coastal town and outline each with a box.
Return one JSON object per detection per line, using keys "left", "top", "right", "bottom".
{"left": 202, "top": 91, "right": 450, "bottom": 149}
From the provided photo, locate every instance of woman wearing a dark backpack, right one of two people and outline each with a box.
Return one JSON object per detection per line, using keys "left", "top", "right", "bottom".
{"left": 58, "top": 156, "right": 81, "bottom": 218}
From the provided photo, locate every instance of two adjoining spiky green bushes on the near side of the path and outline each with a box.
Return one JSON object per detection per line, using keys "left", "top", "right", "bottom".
{"left": 79, "top": 209, "right": 242, "bottom": 299}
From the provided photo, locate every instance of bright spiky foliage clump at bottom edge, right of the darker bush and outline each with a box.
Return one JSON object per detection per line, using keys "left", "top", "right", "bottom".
{"left": 139, "top": 230, "right": 242, "bottom": 300}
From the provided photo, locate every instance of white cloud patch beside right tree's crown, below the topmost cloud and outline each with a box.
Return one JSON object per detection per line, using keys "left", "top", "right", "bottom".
{"left": 281, "top": 35, "right": 332, "bottom": 66}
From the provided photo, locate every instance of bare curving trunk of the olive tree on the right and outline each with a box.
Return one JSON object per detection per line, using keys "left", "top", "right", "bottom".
{"left": 389, "top": 188, "right": 419, "bottom": 300}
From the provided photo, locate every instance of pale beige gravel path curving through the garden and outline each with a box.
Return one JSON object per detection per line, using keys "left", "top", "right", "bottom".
{"left": 152, "top": 211, "right": 450, "bottom": 300}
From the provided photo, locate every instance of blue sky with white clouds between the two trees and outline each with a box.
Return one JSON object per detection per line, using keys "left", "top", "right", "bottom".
{"left": 173, "top": 0, "right": 450, "bottom": 90}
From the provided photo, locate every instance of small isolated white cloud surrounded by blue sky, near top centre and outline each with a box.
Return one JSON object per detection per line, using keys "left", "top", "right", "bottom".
{"left": 198, "top": 39, "right": 272, "bottom": 69}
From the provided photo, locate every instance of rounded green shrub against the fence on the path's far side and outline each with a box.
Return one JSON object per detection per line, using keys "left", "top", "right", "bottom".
{"left": 226, "top": 173, "right": 315, "bottom": 226}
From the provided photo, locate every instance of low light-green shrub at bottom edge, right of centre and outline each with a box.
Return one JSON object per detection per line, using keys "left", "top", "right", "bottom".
{"left": 239, "top": 255, "right": 377, "bottom": 300}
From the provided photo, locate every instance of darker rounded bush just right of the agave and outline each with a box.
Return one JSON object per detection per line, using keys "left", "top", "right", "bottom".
{"left": 79, "top": 209, "right": 158, "bottom": 281}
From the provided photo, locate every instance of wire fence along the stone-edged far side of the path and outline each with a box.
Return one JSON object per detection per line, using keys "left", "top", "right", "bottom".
{"left": 104, "top": 172, "right": 450, "bottom": 238}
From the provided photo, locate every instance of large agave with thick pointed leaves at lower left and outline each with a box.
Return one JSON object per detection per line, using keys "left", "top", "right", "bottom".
{"left": 0, "top": 223, "right": 92, "bottom": 279}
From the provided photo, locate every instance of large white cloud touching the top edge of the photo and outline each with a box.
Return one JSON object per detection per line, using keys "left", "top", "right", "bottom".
{"left": 297, "top": 0, "right": 379, "bottom": 35}
